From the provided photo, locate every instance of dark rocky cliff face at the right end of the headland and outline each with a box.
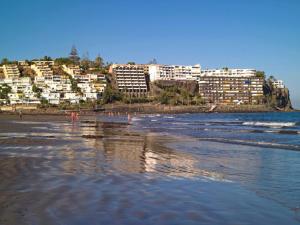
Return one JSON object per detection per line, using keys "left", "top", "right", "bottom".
{"left": 263, "top": 80, "right": 293, "bottom": 111}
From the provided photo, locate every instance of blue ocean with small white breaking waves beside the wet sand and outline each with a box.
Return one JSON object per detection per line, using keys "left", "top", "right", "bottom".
{"left": 103, "top": 112, "right": 300, "bottom": 224}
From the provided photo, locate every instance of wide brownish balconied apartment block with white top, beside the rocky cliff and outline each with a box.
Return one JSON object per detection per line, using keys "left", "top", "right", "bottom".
{"left": 199, "top": 69, "right": 264, "bottom": 104}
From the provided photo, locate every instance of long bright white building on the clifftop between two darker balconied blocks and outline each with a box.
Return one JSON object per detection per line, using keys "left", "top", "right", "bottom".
{"left": 147, "top": 64, "right": 201, "bottom": 81}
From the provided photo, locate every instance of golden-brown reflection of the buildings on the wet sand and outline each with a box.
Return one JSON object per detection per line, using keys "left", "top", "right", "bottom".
{"left": 59, "top": 119, "right": 221, "bottom": 178}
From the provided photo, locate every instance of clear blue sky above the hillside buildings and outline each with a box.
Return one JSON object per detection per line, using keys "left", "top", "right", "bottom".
{"left": 0, "top": 0, "right": 300, "bottom": 108}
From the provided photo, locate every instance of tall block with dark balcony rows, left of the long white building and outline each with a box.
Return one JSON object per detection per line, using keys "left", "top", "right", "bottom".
{"left": 109, "top": 64, "right": 148, "bottom": 96}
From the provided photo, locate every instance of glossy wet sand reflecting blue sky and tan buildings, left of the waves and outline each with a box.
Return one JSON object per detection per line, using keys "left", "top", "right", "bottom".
{"left": 0, "top": 115, "right": 296, "bottom": 225}
